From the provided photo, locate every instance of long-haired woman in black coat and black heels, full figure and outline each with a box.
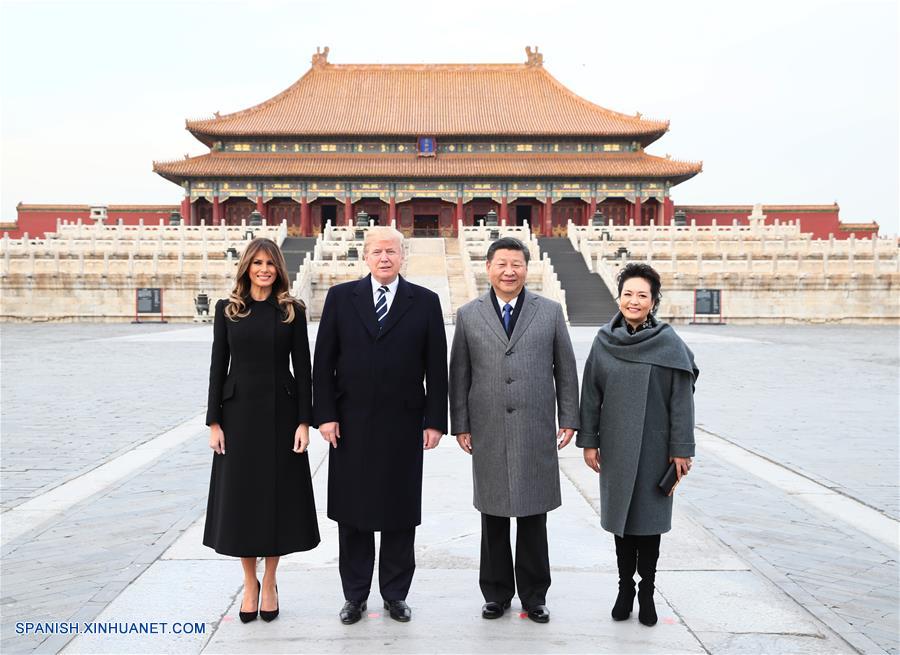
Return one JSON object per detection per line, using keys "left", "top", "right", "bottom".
{"left": 203, "top": 239, "right": 319, "bottom": 623}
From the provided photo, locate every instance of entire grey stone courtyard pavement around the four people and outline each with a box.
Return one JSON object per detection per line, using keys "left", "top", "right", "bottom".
{"left": 0, "top": 325, "right": 898, "bottom": 653}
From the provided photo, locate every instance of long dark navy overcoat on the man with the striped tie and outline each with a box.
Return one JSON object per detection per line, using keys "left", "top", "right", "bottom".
{"left": 313, "top": 276, "right": 447, "bottom": 531}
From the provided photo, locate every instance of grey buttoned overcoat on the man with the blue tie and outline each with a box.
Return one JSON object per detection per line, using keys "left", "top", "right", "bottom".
{"left": 450, "top": 292, "right": 578, "bottom": 516}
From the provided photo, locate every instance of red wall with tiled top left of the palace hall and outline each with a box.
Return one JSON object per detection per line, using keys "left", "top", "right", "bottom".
{"left": 6, "top": 204, "right": 181, "bottom": 239}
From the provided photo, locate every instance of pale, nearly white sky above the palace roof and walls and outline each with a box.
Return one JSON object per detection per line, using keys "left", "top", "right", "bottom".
{"left": 0, "top": 0, "right": 900, "bottom": 234}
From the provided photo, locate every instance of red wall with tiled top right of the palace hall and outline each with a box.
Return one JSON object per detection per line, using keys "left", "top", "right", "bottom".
{"left": 675, "top": 204, "right": 878, "bottom": 239}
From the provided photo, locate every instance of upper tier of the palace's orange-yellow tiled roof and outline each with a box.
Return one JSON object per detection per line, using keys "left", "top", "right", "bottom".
{"left": 187, "top": 55, "right": 669, "bottom": 145}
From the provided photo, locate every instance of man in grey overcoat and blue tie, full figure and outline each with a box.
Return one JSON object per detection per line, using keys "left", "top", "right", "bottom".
{"left": 450, "top": 237, "right": 578, "bottom": 623}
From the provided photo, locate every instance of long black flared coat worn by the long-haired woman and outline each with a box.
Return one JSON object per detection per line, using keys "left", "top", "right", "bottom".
{"left": 203, "top": 296, "right": 319, "bottom": 557}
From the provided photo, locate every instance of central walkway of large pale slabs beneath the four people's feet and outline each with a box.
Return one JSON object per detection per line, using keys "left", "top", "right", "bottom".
{"left": 66, "top": 420, "right": 852, "bottom": 653}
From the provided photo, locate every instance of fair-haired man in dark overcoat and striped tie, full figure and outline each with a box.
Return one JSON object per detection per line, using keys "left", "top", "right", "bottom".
{"left": 313, "top": 227, "right": 447, "bottom": 625}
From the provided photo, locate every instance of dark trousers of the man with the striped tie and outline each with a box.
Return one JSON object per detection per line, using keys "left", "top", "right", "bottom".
{"left": 338, "top": 523, "right": 416, "bottom": 601}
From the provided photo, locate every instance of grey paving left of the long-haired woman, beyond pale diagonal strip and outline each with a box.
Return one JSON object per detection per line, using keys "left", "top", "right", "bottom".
{"left": 0, "top": 324, "right": 209, "bottom": 511}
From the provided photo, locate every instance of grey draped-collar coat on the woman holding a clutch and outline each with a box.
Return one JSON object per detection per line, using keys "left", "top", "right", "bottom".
{"left": 576, "top": 313, "right": 699, "bottom": 536}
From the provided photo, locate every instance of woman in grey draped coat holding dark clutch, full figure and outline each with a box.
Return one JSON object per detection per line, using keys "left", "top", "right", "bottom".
{"left": 576, "top": 263, "right": 699, "bottom": 625}
